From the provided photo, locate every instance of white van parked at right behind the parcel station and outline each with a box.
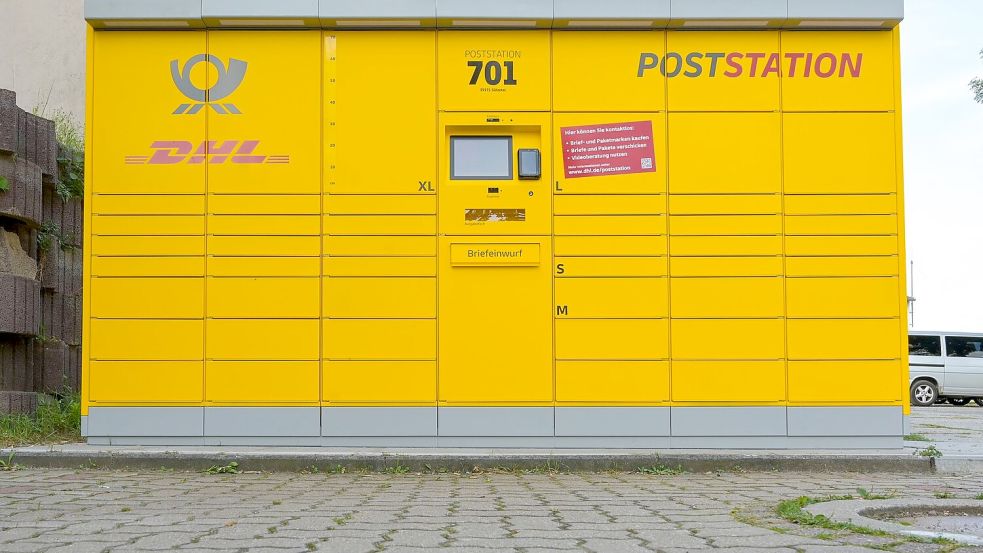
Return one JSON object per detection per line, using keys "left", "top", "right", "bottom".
{"left": 908, "top": 331, "right": 983, "bottom": 407}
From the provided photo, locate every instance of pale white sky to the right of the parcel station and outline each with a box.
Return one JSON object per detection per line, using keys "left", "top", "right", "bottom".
{"left": 901, "top": 0, "right": 983, "bottom": 332}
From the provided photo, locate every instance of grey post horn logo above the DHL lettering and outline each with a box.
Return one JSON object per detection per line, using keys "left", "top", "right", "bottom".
{"left": 171, "top": 54, "right": 248, "bottom": 115}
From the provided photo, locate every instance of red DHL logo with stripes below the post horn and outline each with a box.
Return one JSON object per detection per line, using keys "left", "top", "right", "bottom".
{"left": 126, "top": 140, "right": 290, "bottom": 165}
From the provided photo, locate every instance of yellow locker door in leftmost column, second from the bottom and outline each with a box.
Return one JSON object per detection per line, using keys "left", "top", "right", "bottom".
{"left": 89, "top": 319, "right": 205, "bottom": 361}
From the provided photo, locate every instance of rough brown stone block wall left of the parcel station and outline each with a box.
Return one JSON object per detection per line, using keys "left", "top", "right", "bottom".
{"left": 0, "top": 90, "right": 82, "bottom": 413}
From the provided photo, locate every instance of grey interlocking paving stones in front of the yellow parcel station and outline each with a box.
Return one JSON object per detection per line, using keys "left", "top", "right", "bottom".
{"left": 0, "top": 469, "right": 983, "bottom": 553}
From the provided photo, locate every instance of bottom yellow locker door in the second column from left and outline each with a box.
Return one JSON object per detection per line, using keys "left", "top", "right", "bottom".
{"left": 205, "top": 360, "right": 321, "bottom": 404}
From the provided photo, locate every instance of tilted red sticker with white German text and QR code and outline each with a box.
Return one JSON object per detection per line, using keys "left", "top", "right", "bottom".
{"left": 560, "top": 121, "right": 655, "bottom": 179}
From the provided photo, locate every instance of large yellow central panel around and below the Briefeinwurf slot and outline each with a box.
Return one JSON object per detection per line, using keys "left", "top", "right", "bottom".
{"left": 438, "top": 236, "right": 553, "bottom": 403}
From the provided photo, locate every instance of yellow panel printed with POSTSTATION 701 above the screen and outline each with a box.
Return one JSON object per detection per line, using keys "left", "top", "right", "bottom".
{"left": 440, "top": 31, "right": 551, "bottom": 111}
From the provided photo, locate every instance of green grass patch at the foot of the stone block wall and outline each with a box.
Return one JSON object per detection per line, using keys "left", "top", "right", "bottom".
{"left": 0, "top": 393, "right": 82, "bottom": 447}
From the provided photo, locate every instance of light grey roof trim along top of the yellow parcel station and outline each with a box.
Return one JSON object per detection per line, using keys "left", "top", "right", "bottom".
{"left": 85, "top": 0, "right": 904, "bottom": 29}
